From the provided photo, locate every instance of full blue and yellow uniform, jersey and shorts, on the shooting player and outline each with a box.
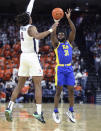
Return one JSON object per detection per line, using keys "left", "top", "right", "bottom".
{"left": 55, "top": 41, "right": 75, "bottom": 86}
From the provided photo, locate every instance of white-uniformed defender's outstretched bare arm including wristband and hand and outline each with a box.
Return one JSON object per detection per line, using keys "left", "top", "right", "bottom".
{"left": 28, "top": 23, "right": 58, "bottom": 39}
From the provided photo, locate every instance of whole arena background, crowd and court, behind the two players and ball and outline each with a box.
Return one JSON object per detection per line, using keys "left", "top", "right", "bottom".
{"left": 0, "top": 0, "right": 101, "bottom": 131}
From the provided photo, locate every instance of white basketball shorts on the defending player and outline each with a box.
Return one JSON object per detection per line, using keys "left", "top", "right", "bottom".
{"left": 18, "top": 53, "right": 43, "bottom": 77}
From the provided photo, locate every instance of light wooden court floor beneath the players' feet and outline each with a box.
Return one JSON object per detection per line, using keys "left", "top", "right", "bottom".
{"left": 0, "top": 103, "right": 101, "bottom": 131}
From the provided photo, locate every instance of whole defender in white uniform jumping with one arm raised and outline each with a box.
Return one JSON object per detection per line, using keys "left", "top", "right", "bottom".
{"left": 5, "top": 0, "right": 58, "bottom": 123}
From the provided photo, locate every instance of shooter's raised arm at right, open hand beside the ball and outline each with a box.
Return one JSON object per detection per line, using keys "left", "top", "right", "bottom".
{"left": 65, "top": 9, "right": 76, "bottom": 43}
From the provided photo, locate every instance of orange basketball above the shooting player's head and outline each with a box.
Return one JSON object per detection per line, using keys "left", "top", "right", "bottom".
{"left": 52, "top": 8, "right": 64, "bottom": 20}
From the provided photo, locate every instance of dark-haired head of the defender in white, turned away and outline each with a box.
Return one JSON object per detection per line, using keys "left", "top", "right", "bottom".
{"left": 16, "top": 12, "right": 32, "bottom": 26}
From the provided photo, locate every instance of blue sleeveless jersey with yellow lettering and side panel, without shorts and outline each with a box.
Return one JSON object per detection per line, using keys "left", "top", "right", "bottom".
{"left": 55, "top": 41, "right": 72, "bottom": 64}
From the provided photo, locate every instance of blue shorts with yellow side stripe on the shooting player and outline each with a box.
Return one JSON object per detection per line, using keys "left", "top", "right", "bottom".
{"left": 55, "top": 66, "right": 75, "bottom": 86}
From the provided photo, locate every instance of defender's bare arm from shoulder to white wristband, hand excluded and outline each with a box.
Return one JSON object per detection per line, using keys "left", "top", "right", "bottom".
{"left": 28, "top": 26, "right": 51, "bottom": 39}
